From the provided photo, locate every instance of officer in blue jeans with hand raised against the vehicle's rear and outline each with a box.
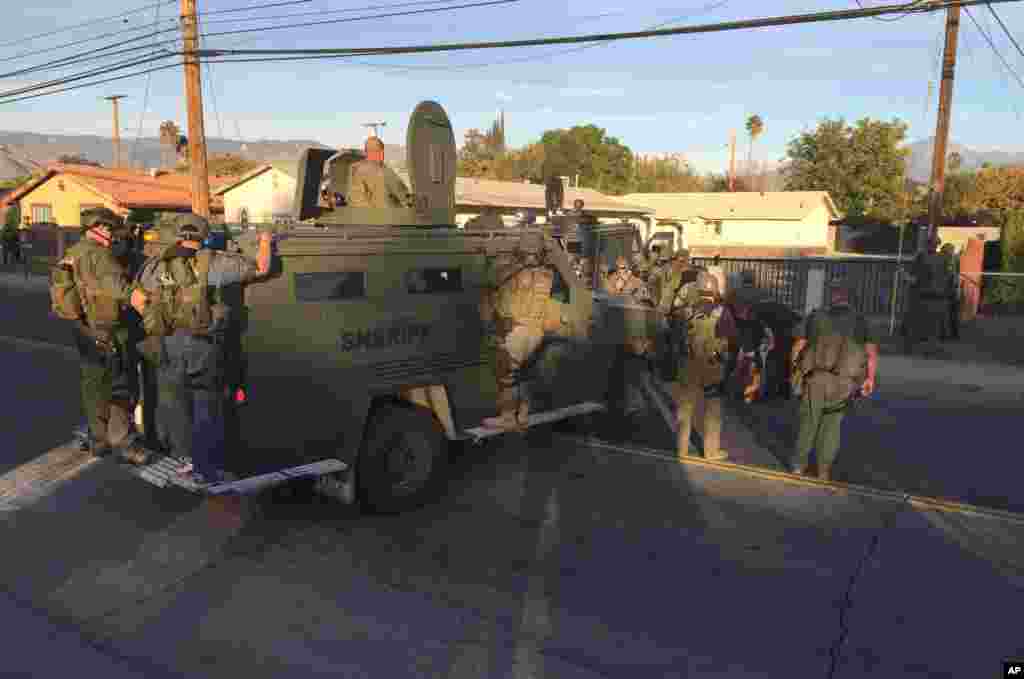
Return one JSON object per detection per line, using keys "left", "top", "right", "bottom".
{"left": 140, "top": 214, "right": 271, "bottom": 483}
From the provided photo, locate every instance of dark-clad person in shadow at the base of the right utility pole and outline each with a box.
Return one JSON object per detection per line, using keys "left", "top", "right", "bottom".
{"left": 903, "top": 234, "right": 950, "bottom": 354}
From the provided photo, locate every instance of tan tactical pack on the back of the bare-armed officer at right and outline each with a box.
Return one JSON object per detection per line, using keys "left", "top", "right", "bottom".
{"left": 799, "top": 319, "right": 867, "bottom": 402}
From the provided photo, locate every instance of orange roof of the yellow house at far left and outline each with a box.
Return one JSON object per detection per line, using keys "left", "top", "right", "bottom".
{"left": 3, "top": 163, "right": 233, "bottom": 210}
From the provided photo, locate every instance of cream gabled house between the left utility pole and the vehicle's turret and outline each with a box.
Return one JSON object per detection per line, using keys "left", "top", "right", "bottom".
{"left": 216, "top": 161, "right": 298, "bottom": 224}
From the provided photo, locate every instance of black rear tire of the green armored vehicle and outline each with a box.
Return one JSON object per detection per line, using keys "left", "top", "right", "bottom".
{"left": 355, "top": 404, "right": 449, "bottom": 514}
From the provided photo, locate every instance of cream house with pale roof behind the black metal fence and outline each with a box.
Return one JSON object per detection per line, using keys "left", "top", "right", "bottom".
{"left": 616, "top": 192, "right": 842, "bottom": 257}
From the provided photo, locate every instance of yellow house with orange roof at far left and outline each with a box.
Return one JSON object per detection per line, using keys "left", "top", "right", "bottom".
{"left": 0, "top": 163, "right": 232, "bottom": 256}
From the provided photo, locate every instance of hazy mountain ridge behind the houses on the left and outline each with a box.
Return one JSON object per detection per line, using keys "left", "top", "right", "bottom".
{"left": 0, "top": 131, "right": 406, "bottom": 181}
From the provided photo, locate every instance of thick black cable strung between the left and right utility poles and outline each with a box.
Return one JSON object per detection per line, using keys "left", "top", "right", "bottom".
{"left": 200, "top": 0, "right": 1020, "bottom": 63}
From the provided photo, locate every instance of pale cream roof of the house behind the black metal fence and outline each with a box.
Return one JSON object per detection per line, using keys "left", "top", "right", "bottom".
{"left": 616, "top": 190, "right": 842, "bottom": 221}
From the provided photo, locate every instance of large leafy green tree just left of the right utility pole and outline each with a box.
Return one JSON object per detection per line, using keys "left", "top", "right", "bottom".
{"left": 785, "top": 118, "right": 907, "bottom": 219}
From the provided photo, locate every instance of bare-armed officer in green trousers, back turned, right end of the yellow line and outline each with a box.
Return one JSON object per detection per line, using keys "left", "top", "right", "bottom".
{"left": 792, "top": 280, "right": 879, "bottom": 480}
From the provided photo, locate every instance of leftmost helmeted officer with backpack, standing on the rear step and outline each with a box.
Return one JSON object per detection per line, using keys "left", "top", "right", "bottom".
{"left": 50, "top": 208, "right": 147, "bottom": 464}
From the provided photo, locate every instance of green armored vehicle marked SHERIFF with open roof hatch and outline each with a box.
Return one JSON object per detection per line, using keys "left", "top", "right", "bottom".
{"left": 117, "top": 101, "right": 656, "bottom": 511}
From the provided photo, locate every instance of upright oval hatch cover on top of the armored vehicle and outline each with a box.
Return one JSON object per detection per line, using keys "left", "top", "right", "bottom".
{"left": 406, "top": 101, "right": 456, "bottom": 224}
